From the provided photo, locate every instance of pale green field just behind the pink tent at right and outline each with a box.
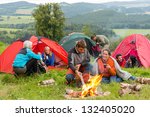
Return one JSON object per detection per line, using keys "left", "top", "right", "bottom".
{"left": 113, "top": 29, "right": 150, "bottom": 38}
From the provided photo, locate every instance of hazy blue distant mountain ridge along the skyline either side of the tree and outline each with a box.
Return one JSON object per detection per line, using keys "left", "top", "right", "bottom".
{"left": 0, "top": 0, "right": 150, "bottom": 18}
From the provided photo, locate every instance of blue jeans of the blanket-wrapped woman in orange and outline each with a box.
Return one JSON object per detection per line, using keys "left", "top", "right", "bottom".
{"left": 102, "top": 76, "right": 123, "bottom": 83}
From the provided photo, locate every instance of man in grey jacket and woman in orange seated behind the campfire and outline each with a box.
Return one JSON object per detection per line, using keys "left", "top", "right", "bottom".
{"left": 66, "top": 37, "right": 136, "bottom": 85}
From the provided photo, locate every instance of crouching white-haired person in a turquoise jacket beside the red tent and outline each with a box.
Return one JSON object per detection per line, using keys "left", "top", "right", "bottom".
{"left": 13, "top": 40, "right": 46, "bottom": 75}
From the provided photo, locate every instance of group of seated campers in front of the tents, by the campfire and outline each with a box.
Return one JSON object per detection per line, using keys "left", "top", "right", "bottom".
{"left": 13, "top": 37, "right": 135, "bottom": 88}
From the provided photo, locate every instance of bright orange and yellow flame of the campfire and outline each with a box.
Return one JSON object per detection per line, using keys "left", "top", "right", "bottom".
{"left": 81, "top": 75, "right": 102, "bottom": 98}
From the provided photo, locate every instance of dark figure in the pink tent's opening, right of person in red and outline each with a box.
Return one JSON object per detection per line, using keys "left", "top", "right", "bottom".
{"left": 125, "top": 55, "right": 139, "bottom": 68}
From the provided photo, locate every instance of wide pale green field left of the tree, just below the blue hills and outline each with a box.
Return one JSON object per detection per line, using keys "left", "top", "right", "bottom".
{"left": 0, "top": 16, "right": 34, "bottom": 24}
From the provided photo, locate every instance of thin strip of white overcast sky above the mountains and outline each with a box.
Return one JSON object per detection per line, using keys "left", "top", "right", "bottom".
{"left": 0, "top": 0, "right": 133, "bottom": 4}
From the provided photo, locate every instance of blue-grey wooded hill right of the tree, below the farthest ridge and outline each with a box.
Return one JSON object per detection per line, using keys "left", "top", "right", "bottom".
{"left": 67, "top": 10, "right": 150, "bottom": 28}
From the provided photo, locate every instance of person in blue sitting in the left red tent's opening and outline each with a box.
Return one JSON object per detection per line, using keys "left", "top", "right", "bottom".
{"left": 42, "top": 46, "right": 55, "bottom": 66}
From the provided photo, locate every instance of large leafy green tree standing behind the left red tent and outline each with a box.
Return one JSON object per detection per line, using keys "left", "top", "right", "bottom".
{"left": 32, "top": 3, "right": 65, "bottom": 41}
